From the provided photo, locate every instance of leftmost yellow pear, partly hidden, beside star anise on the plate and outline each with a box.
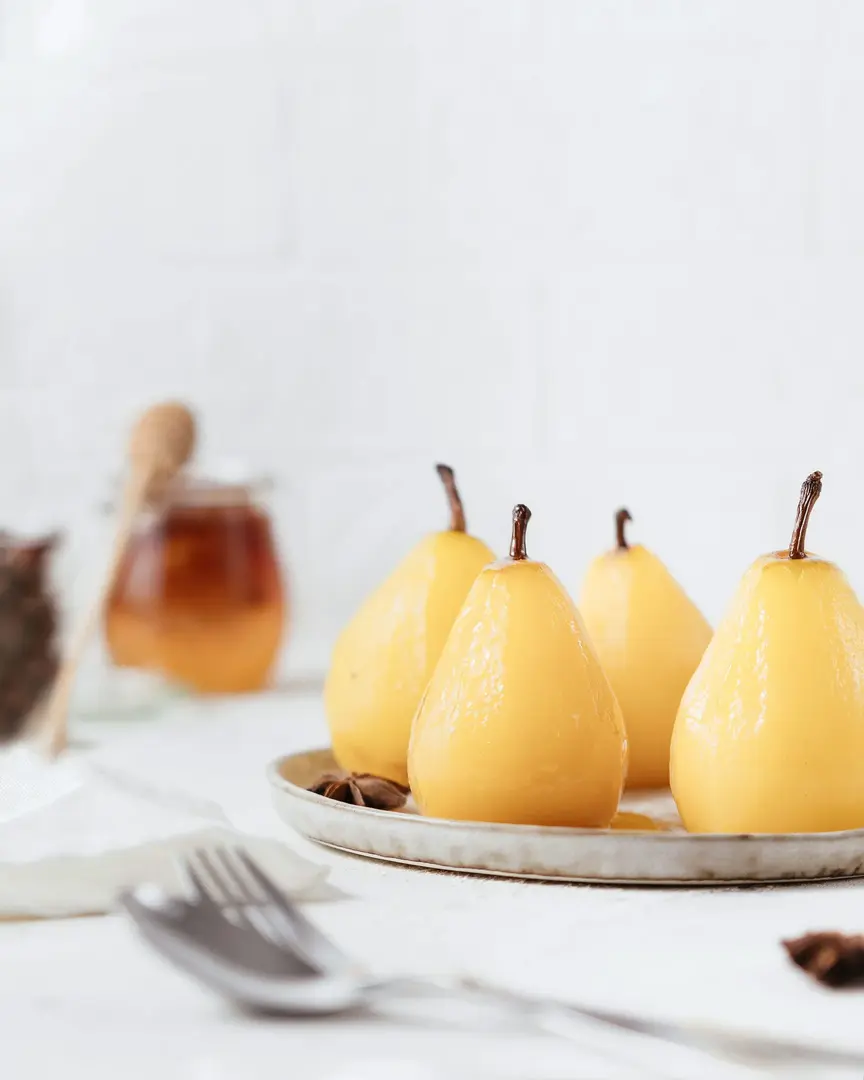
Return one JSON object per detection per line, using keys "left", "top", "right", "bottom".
{"left": 324, "top": 465, "right": 495, "bottom": 784}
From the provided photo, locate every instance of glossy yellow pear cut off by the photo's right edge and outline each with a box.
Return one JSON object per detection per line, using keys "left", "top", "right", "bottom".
{"left": 672, "top": 472, "right": 864, "bottom": 833}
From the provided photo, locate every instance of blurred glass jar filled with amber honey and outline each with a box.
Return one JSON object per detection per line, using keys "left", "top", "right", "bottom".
{"left": 104, "top": 476, "right": 287, "bottom": 693}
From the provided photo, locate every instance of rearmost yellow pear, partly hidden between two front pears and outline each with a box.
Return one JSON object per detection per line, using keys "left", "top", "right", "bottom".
{"left": 579, "top": 509, "right": 711, "bottom": 787}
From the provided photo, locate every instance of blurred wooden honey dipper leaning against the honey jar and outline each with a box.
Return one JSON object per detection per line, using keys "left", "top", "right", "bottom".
{"left": 42, "top": 402, "right": 195, "bottom": 757}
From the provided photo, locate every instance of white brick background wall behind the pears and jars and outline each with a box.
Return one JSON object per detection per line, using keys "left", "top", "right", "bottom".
{"left": 0, "top": 0, "right": 864, "bottom": 667}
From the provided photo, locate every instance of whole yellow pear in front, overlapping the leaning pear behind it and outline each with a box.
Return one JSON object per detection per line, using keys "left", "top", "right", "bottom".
{"left": 408, "top": 505, "right": 626, "bottom": 828}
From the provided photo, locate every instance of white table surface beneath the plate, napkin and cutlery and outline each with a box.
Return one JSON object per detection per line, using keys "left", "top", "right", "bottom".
{"left": 0, "top": 688, "right": 864, "bottom": 1080}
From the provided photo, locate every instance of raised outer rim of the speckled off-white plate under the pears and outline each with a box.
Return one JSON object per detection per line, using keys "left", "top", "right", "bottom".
{"left": 267, "top": 747, "right": 864, "bottom": 887}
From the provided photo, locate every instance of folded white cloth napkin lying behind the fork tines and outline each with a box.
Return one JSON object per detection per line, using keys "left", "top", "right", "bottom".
{"left": 0, "top": 745, "right": 327, "bottom": 918}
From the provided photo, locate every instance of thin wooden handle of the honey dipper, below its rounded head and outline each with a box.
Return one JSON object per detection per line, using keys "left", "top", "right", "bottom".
{"left": 43, "top": 468, "right": 152, "bottom": 758}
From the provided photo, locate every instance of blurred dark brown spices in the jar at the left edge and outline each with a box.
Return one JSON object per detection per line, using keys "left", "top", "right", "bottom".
{"left": 0, "top": 531, "right": 60, "bottom": 742}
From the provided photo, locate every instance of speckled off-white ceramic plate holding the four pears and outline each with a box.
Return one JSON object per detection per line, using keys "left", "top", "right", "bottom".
{"left": 268, "top": 750, "right": 864, "bottom": 886}
